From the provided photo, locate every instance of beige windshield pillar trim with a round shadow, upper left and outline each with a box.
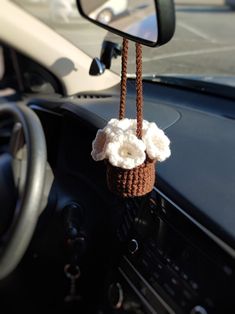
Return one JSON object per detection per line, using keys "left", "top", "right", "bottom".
{"left": 0, "top": 0, "right": 120, "bottom": 96}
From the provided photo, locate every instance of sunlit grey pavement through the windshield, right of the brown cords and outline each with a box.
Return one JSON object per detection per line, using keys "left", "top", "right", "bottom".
{"left": 138, "top": 5, "right": 235, "bottom": 76}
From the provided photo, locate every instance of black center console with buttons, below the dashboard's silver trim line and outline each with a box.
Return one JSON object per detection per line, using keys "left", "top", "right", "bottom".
{"left": 108, "top": 189, "right": 235, "bottom": 314}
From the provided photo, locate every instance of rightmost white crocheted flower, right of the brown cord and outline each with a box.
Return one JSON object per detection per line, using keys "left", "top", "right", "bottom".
{"left": 143, "top": 122, "right": 171, "bottom": 161}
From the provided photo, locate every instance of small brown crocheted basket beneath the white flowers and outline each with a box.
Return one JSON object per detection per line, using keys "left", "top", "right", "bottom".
{"left": 106, "top": 159, "right": 155, "bottom": 197}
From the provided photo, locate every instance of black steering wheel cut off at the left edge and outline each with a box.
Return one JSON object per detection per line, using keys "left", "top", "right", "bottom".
{"left": 0, "top": 103, "right": 47, "bottom": 280}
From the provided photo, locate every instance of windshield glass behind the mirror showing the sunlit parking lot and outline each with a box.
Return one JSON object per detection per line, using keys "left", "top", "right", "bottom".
{"left": 9, "top": 0, "right": 235, "bottom": 86}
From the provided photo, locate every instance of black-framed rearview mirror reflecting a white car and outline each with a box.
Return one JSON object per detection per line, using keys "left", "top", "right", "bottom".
{"left": 77, "top": 0, "right": 175, "bottom": 46}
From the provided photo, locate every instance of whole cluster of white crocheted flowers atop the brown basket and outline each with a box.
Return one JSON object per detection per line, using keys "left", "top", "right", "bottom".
{"left": 91, "top": 118, "right": 171, "bottom": 169}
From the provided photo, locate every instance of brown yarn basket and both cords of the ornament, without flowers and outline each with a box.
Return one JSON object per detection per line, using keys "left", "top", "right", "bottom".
{"left": 106, "top": 38, "right": 155, "bottom": 197}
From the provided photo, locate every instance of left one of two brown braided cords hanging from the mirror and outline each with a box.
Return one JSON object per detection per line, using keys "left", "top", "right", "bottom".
{"left": 119, "top": 38, "right": 128, "bottom": 120}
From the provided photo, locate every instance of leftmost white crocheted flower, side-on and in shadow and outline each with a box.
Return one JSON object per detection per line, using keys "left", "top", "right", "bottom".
{"left": 91, "top": 129, "right": 107, "bottom": 161}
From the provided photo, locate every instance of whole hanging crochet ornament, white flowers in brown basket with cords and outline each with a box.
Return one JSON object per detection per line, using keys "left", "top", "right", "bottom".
{"left": 91, "top": 38, "right": 170, "bottom": 197}
